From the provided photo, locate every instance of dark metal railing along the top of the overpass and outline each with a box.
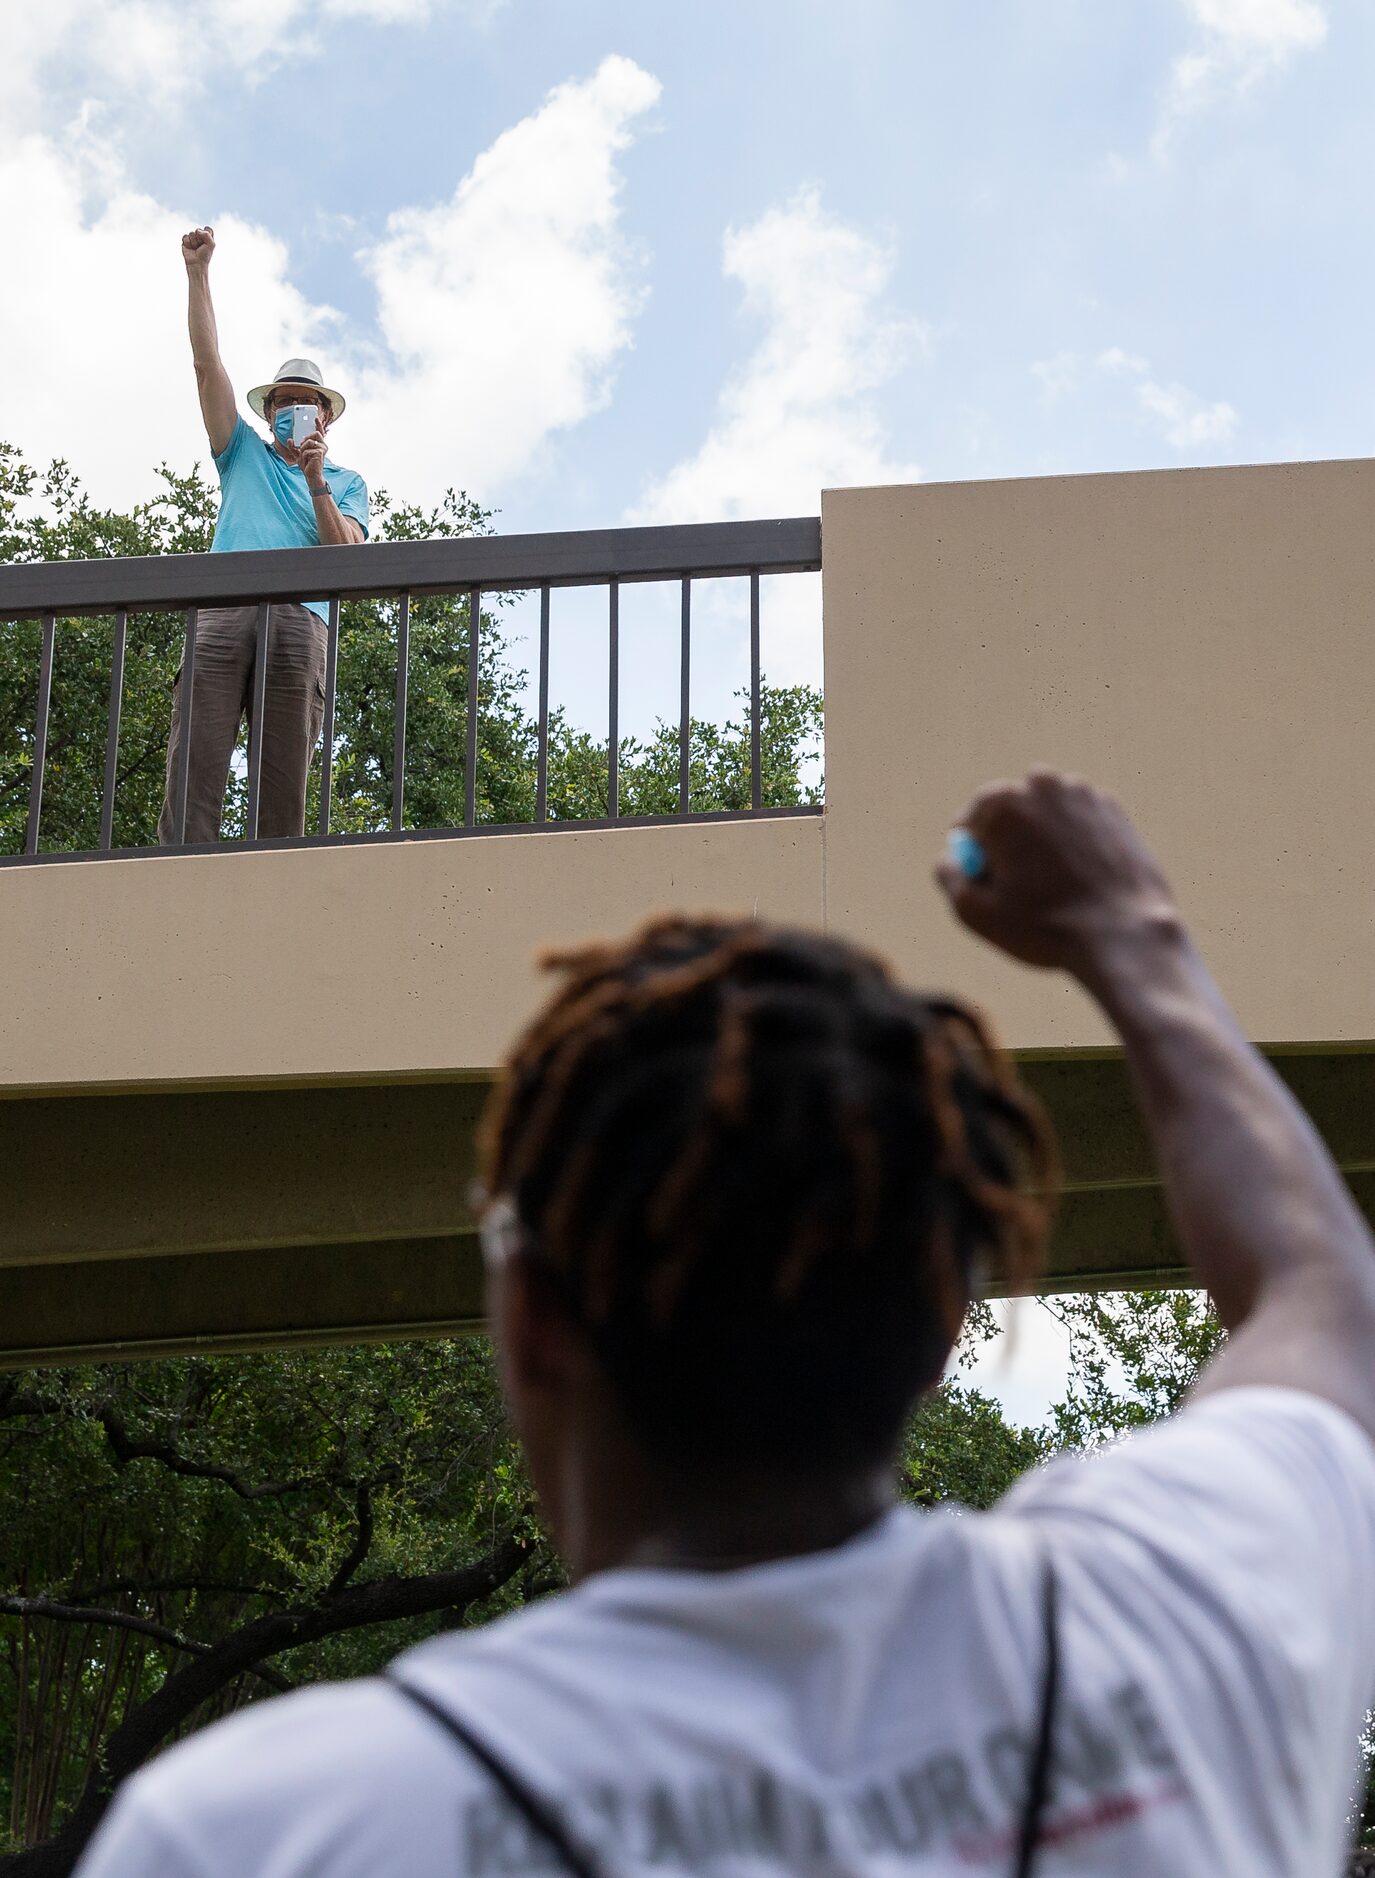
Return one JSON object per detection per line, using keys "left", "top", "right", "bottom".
{"left": 0, "top": 516, "right": 821, "bottom": 866}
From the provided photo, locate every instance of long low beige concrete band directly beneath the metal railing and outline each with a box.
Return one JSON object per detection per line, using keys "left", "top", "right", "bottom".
{"left": 0, "top": 817, "right": 823, "bottom": 1091}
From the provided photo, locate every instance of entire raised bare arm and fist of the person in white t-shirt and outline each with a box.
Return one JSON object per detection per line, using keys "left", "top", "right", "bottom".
{"left": 939, "top": 772, "right": 1375, "bottom": 1437}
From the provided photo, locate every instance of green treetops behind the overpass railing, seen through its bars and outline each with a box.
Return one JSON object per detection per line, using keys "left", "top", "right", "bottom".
{"left": 0, "top": 443, "right": 821, "bottom": 853}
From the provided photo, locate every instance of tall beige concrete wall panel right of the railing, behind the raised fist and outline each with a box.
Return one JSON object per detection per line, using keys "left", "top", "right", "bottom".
{"left": 823, "top": 462, "right": 1375, "bottom": 1046}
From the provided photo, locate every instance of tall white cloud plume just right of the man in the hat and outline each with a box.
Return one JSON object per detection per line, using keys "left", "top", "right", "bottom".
{"left": 349, "top": 56, "right": 659, "bottom": 492}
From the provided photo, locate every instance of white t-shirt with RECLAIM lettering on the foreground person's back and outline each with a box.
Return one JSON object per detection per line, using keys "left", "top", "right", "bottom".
{"left": 79, "top": 1388, "right": 1375, "bottom": 1878}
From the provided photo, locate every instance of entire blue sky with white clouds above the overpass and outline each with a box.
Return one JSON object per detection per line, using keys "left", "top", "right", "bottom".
{"left": 0, "top": 0, "right": 1352, "bottom": 1412}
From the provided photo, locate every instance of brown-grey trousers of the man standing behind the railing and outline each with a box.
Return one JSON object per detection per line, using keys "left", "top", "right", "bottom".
{"left": 158, "top": 605, "right": 327, "bottom": 847}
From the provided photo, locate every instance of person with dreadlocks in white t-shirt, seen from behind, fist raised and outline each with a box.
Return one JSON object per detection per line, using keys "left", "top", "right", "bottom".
{"left": 81, "top": 772, "right": 1375, "bottom": 1878}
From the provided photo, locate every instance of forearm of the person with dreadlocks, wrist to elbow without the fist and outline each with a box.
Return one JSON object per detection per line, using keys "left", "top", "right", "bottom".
{"left": 1080, "top": 926, "right": 1375, "bottom": 1330}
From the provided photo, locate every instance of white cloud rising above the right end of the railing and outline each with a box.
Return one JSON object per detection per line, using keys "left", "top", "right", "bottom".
{"left": 631, "top": 190, "right": 924, "bottom": 522}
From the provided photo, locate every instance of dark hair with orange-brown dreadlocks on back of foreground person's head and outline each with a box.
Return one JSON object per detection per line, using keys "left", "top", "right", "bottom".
{"left": 485, "top": 918, "right": 1054, "bottom": 1470}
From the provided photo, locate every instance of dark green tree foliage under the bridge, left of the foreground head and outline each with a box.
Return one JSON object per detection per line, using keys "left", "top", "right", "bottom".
{"left": 0, "top": 1339, "right": 540, "bottom": 1872}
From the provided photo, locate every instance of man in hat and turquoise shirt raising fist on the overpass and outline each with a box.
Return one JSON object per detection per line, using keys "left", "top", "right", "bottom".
{"left": 158, "top": 227, "right": 368, "bottom": 847}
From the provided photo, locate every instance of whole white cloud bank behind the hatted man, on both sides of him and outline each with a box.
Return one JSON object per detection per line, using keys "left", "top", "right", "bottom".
{"left": 0, "top": 58, "right": 659, "bottom": 503}
